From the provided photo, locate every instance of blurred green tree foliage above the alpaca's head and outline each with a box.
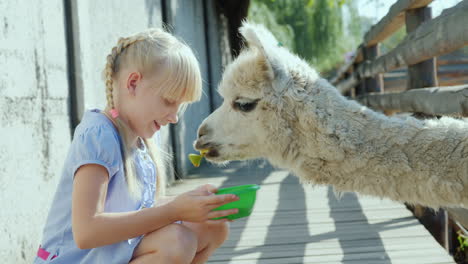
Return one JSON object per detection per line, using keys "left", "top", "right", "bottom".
{"left": 248, "top": 0, "right": 362, "bottom": 72}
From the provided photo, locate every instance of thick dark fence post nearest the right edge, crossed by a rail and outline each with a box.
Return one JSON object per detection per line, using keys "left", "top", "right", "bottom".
{"left": 406, "top": 7, "right": 438, "bottom": 90}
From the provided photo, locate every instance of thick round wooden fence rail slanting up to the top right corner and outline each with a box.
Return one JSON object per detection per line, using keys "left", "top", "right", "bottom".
{"left": 357, "top": 0, "right": 468, "bottom": 78}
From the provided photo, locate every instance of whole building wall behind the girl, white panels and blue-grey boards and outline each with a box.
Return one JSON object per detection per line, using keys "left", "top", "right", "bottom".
{"left": 0, "top": 0, "right": 231, "bottom": 263}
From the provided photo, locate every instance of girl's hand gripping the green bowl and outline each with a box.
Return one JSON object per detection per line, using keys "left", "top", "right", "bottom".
{"left": 167, "top": 184, "right": 239, "bottom": 222}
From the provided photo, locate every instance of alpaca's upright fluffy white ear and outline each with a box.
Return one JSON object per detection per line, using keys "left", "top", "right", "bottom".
{"left": 239, "top": 21, "right": 285, "bottom": 93}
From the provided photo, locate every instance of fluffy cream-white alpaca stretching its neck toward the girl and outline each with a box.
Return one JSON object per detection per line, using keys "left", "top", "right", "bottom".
{"left": 195, "top": 23, "right": 468, "bottom": 208}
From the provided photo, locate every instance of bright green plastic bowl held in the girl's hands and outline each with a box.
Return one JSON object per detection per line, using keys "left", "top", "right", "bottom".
{"left": 213, "top": 184, "right": 260, "bottom": 220}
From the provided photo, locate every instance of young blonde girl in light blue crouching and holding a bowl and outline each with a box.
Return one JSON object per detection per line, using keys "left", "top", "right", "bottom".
{"left": 34, "top": 29, "right": 238, "bottom": 264}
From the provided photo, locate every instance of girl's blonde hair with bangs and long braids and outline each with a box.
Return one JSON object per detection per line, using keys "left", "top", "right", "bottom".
{"left": 104, "top": 28, "right": 202, "bottom": 198}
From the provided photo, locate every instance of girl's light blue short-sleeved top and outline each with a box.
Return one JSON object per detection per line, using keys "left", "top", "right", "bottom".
{"left": 34, "top": 109, "right": 156, "bottom": 264}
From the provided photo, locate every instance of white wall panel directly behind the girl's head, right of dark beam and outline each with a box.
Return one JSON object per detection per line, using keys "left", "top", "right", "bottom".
{"left": 72, "top": 0, "right": 162, "bottom": 118}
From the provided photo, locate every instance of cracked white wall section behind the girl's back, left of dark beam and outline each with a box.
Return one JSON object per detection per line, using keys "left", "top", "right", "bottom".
{"left": 0, "top": 0, "right": 70, "bottom": 263}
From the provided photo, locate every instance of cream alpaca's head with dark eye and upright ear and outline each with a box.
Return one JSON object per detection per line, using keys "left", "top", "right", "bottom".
{"left": 195, "top": 23, "right": 318, "bottom": 162}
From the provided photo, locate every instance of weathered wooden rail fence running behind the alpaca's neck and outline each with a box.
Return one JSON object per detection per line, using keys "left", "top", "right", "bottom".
{"left": 330, "top": 0, "right": 468, "bottom": 258}
